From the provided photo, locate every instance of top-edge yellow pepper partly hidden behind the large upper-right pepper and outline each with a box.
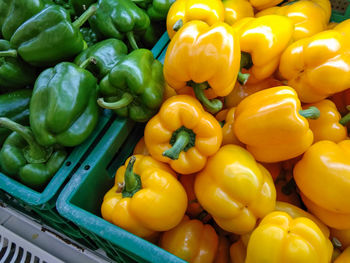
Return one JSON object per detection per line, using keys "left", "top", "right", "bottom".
{"left": 256, "top": 0, "right": 331, "bottom": 41}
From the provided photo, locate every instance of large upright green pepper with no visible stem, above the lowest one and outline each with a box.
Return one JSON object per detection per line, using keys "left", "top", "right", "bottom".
{"left": 29, "top": 62, "right": 99, "bottom": 147}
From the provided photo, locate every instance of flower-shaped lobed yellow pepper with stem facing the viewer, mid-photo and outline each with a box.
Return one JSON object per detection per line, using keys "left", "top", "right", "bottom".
{"left": 145, "top": 95, "right": 222, "bottom": 174}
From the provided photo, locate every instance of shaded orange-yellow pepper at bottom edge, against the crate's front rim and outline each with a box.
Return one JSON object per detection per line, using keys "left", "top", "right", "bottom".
{"left": 160, "top": 216, "right": 219, "bottom": 263}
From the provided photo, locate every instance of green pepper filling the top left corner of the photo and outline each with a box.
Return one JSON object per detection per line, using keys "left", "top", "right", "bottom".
{"left": 0, "top": 0, "right": 52, "bottom": 40}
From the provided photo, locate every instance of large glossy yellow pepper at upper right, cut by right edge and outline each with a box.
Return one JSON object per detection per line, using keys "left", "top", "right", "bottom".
{"left": 279, "top": 20, "right": 350, "bottom": 103}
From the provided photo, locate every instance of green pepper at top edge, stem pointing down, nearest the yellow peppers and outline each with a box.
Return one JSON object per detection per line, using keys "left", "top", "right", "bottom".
{"left": 89, "top": 0, "right": 150, "bottom": 49}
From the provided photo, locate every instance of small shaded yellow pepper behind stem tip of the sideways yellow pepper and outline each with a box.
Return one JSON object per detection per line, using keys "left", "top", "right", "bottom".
{"left": 303, "top": 100, "right": 348, "bottom": 143}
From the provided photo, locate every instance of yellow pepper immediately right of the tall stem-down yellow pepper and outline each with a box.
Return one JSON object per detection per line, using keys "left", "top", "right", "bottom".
{"left": 233, "top": 15, "right": 294, "bottom": 83}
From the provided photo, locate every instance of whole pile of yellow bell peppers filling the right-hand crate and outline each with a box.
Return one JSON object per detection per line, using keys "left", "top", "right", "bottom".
{"left": 101, "top": 0, "right": 350, "bottom": 263}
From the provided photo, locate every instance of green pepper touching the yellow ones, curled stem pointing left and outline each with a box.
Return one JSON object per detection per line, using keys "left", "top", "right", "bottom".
{"left": 98, "top": 49, "right": 165, "bottom": 122}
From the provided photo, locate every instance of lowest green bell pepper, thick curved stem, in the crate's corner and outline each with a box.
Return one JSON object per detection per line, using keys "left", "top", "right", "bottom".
{"left": 0, "top": 118, "right": 67, "bottom": 189}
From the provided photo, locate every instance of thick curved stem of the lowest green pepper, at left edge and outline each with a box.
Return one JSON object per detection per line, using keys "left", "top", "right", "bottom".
{"left": 0, "top": 118, "right": 52, "bottom": 163}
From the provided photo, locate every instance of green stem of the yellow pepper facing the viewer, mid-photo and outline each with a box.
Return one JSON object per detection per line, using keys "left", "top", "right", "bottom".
{"left": 163, "top": 126, "right": 196, "bottom": 160}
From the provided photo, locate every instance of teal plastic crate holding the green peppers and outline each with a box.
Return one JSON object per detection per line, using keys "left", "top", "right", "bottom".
{"left": 0, "top": 34, "right": 168, "bottom": 249}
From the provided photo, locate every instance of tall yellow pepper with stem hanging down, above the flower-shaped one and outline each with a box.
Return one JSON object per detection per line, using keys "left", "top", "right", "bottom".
{"left": 164, "top": 21, "right": 240, "bottom": 113}
